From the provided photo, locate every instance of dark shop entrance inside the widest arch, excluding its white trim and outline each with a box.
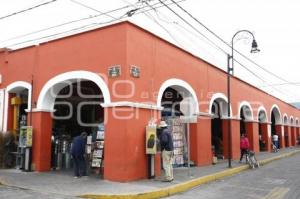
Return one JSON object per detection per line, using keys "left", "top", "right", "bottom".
{"left": 51, "top": 80, "right": 104, "bottom": 173}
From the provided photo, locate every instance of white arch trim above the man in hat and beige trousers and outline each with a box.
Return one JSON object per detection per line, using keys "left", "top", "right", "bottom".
{"left": 157, "top": 78, "right": 200, "bottom": 114}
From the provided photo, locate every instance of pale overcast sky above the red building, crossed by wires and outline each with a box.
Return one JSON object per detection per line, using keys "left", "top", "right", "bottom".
{"left": 0, "top": 0, "right": 300, "bottom": 102}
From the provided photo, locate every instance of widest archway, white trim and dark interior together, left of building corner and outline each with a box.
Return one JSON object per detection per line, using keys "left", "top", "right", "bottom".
{"left": 34, "top": 71, "right": 110, "bottom": 174}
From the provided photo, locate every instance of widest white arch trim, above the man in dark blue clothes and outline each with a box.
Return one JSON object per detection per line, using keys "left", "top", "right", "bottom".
{"left": 36, "top": 70, "right": 111, "bottom": 111}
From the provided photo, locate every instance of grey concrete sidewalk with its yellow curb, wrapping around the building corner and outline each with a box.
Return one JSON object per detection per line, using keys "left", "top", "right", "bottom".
{"left": 0, "top": 147, "right": 300, "bottom": 198}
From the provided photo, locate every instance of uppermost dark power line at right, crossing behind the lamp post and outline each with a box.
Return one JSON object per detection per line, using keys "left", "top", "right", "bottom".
{"left": 171, "top": 0, "right": 289, "bottom": 82}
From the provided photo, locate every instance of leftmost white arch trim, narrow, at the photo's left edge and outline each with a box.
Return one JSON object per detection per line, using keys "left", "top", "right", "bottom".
{"left": 3, "top": 81, "right": 32, "bottom": 131}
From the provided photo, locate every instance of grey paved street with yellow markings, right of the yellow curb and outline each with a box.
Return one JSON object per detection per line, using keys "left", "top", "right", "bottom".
{"left": 168, "top": 154, "right": 300, "bottom": 199}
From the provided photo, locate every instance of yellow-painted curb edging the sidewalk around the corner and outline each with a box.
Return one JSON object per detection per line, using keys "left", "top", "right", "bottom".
{"left": 78, "top": 150, "right": 300, "bottom": 199}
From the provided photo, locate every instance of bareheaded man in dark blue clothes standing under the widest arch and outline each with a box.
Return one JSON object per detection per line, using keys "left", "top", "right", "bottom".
{"left": 71, "top": 132, "right": 87, "bottom": 178}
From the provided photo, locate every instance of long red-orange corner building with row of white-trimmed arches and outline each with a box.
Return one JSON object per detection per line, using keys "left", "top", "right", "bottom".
{"left": 0, "top": 22, "right": 300, "bottom": 182}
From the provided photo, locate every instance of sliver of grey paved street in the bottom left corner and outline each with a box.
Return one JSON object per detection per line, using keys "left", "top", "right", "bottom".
{"left": 0, "top": 186, "right": 75, "bottom": 199}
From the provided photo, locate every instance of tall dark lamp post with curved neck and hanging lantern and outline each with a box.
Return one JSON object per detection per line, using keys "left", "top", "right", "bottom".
{"left": 227, "top": 30, "right": 260, "bottom": 168}
